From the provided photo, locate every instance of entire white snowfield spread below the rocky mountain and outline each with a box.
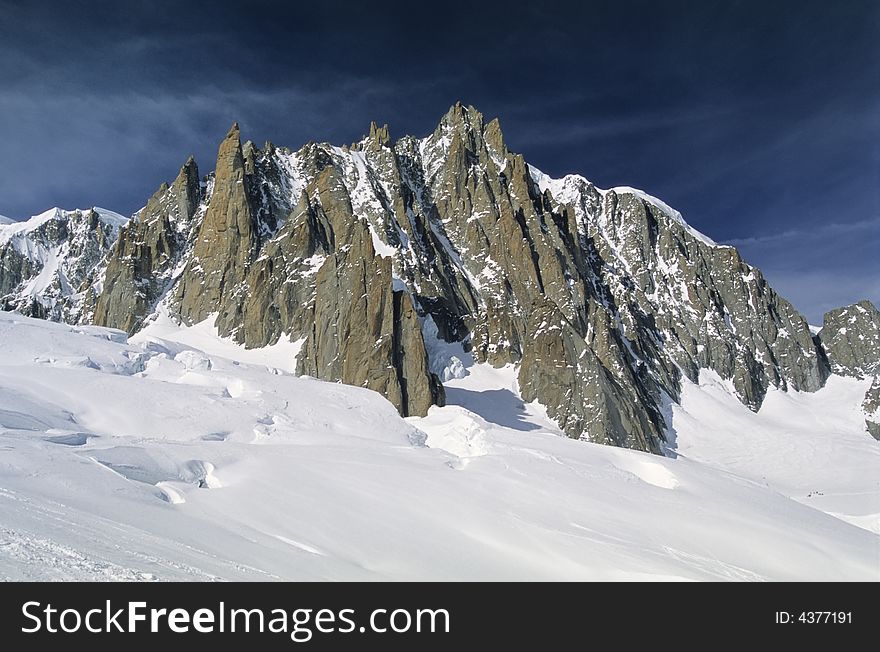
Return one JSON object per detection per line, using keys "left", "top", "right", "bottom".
{"left": 0, "top": 313, "right": 880, "bottom": 580}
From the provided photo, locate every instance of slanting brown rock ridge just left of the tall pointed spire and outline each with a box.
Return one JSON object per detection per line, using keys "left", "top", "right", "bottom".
{"left": 89, "top": 157, "right": 201, "bottom": 333}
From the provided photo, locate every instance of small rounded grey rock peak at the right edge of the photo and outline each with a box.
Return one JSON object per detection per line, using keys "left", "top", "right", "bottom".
{"left": 819, "top": 300, "right": 880, "bottom": 378}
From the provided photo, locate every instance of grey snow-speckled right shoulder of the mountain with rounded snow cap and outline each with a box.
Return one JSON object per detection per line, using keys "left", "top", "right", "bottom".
{"left": 535, "top": 173, "right": 829, "bottom": 410}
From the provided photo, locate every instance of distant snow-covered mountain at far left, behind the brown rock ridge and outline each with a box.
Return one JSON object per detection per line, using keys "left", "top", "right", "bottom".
{"left": 0, "top": 207, "right": 128, "bottom": 321}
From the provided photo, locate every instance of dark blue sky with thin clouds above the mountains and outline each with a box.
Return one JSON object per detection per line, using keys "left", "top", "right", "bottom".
{"left": 0, "top": 0, "right": 880, "bottom": 323}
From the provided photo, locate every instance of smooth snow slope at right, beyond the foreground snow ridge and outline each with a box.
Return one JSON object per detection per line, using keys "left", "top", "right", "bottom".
{"left": 671, "top": 371, "right": 880, "bottom": 532}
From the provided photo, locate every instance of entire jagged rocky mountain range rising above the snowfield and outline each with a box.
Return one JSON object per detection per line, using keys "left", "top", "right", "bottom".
{"left": 0, "top": 104, "right": 878, "bottom": 453}
